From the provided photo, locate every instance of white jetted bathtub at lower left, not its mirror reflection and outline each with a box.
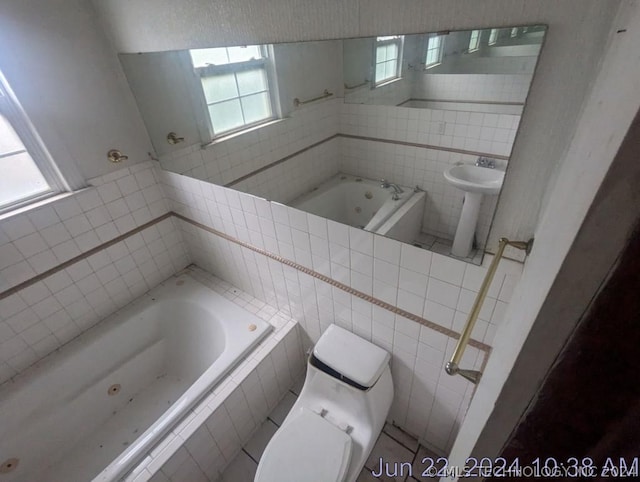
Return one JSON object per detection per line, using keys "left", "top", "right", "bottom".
{"left": 0, "top": 274, "right": 271, "bottom": 482}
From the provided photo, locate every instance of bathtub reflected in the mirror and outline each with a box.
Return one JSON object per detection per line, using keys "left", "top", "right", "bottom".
{"left": 289, "top": 173, "right": 424, "bottom": 233}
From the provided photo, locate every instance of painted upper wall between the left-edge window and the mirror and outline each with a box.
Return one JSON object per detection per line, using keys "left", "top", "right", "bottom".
{"left": 0, "top": 0, "right": 150, "bottom": 184}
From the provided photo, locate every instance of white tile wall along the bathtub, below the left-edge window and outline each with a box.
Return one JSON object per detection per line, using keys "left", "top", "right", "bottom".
{"left": 0, "top": 162, "right": 189, "bottom": 383}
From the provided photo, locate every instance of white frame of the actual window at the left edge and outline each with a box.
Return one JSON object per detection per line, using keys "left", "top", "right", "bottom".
{"left": 0, "top": 72, "right": 71, "bottom": 215}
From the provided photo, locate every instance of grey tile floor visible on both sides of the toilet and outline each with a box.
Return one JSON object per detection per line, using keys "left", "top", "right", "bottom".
{"left": 222, "top": 378, "right": 439, "bottom": 482}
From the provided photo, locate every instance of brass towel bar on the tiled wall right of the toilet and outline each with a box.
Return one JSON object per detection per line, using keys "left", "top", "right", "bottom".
{"left": 444, "top": 238, "right": 533, "bottom": 383}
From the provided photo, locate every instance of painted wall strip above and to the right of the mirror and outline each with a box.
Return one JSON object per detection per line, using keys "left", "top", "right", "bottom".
{"left": 94, "top": 0, "right": 620, "bottom": 252}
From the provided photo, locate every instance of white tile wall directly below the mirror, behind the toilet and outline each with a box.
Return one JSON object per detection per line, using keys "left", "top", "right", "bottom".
{"left": 162, "top": 172, "right": 521, "bottom": 452}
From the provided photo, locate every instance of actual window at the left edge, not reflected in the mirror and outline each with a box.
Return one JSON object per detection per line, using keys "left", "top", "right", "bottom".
{"left": 0, "top": 73, "right": 63, "bottom": 212}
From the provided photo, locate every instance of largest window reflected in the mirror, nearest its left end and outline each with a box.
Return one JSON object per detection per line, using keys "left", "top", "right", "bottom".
{"left": 190, "top": 45, "right": 275, "bottom": 138}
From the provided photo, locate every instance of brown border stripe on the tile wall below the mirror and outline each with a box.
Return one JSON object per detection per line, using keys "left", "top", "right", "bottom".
{"left": 172, "top": 212, "right": 491, "bottom": 354}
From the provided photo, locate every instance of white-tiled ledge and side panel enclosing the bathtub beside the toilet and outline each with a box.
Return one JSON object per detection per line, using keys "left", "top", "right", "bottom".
{"left": 124, "top": 269, "right": 305, "bottom": 482}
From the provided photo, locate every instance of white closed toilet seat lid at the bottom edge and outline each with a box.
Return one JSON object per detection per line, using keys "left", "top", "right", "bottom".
{"left": 255, "top": 408, "right": 351, "bottom": 482}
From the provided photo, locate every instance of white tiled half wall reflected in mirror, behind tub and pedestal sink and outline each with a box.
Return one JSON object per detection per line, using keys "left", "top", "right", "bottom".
{"left": 162, "top": 99, "right": 520, "bottom": 247}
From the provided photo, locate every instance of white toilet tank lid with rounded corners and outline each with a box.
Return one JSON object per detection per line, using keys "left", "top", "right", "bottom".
{"left": 313, "top": 325, "right": 390, "bottom": 388}
